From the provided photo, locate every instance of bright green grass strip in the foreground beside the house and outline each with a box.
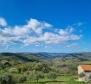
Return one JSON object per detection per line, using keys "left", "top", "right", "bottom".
{"left": 22, "top": 75, "right": 91, "bottom": 84}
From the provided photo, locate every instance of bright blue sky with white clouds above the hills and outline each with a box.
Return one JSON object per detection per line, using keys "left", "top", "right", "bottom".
{"left": 0, "top": 0, "right": 91, "bottom": 53}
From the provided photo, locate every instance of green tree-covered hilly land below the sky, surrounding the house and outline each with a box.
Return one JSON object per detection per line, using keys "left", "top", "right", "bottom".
{"left": 0, "top": 53, "right": 91, "bottom": 84}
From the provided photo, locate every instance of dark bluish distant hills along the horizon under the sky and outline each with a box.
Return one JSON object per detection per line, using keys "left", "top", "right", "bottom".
{"left": 0, "top": 52, "right": 91, "bottom": 61}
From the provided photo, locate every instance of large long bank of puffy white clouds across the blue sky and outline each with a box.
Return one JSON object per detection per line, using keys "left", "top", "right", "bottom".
{"left": 0, "top": 19, "right": 81, "bottom": 46}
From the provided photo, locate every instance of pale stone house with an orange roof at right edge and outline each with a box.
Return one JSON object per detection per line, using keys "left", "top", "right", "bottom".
{"left": 78, "top": 65, "right": 91, "bottom": 82}
